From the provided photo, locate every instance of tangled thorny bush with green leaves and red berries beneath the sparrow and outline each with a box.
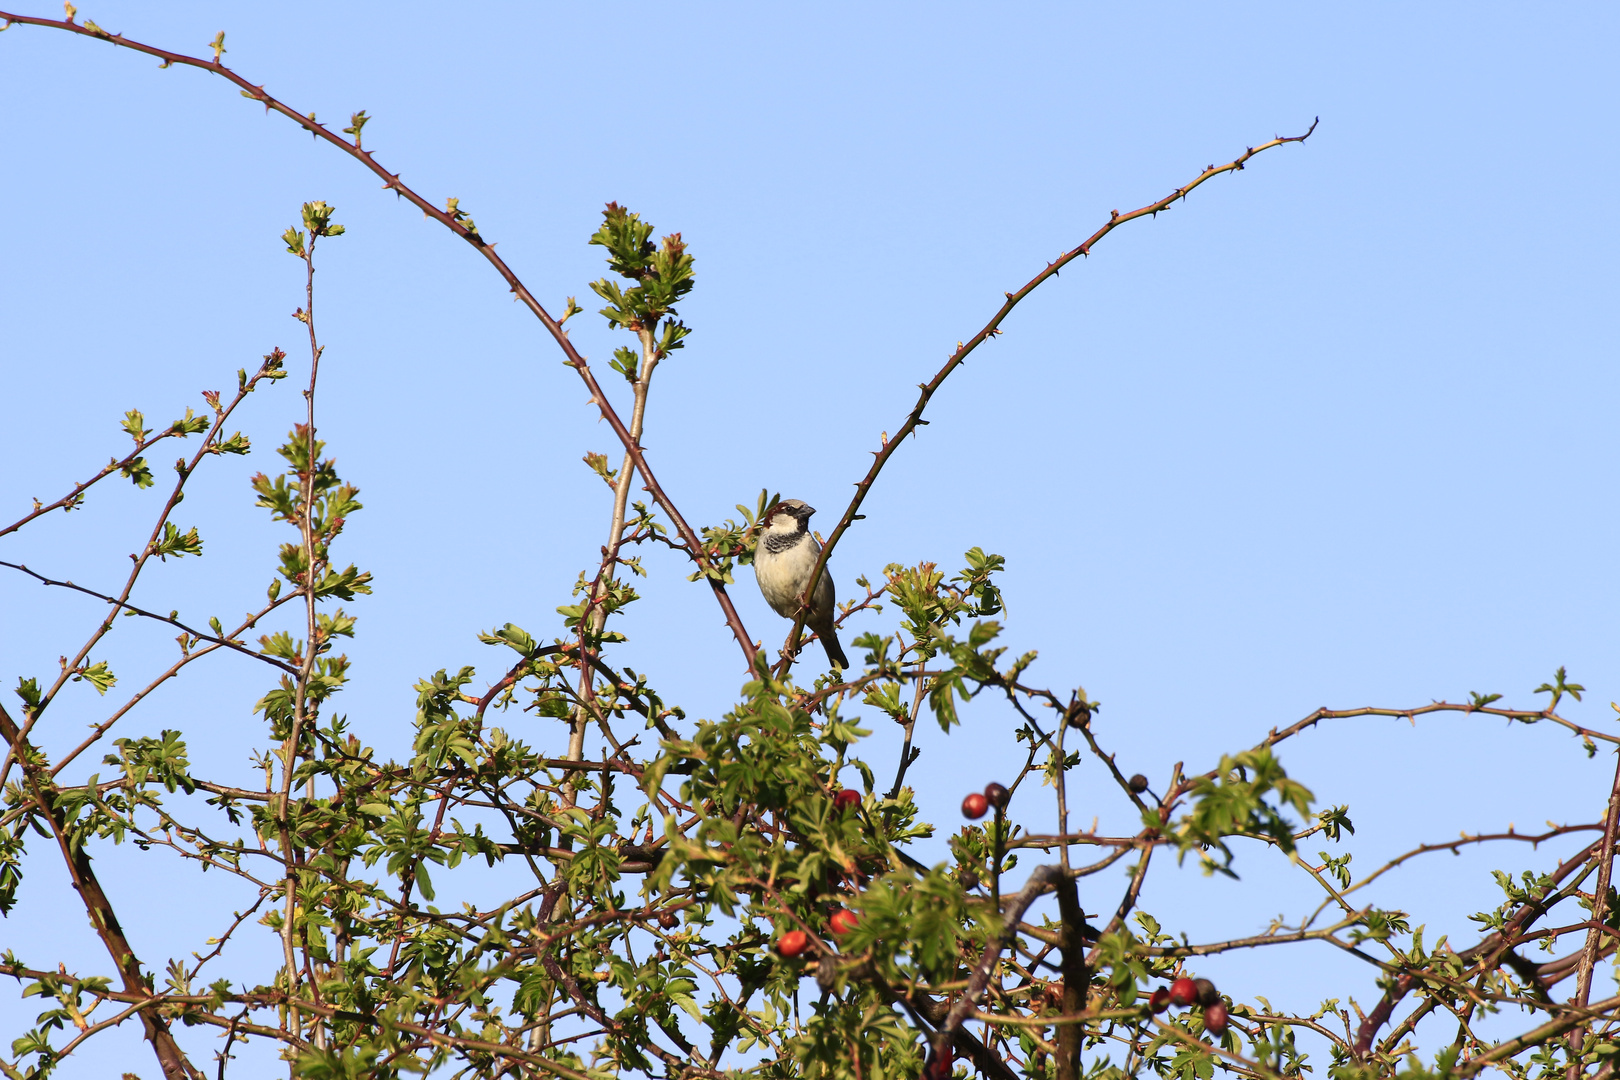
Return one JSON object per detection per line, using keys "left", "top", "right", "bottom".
{"left": 0, "top": 5, "right": 1620, "bottom": 1080}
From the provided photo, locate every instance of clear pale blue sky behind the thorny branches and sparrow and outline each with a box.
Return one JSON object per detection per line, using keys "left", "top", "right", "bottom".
{"left": 0, "top": 2, "right": 1620, "bottom": 1077}
